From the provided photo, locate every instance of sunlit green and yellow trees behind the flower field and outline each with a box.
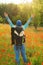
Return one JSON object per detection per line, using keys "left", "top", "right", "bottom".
{"left": 0, "top": 0, "right": 43, "bottom": 28}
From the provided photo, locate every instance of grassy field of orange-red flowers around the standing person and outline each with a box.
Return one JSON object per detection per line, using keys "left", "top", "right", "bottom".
{"left": 0, "top": 24, "right": 43, "bottom": 65}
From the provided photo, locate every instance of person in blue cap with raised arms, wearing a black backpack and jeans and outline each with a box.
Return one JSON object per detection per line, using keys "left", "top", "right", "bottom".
{"left": 4, "top": 12, "right": 34, "bottom": 65}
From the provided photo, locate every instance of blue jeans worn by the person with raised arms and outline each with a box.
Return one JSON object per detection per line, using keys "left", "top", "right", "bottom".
{"left": 14, "top": 44, "right": 27, "bottom": 65}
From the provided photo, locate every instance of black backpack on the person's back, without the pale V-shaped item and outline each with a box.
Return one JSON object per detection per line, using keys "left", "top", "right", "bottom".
{"left": 11, "top": 27, "right": 24, "bottom": 45}
